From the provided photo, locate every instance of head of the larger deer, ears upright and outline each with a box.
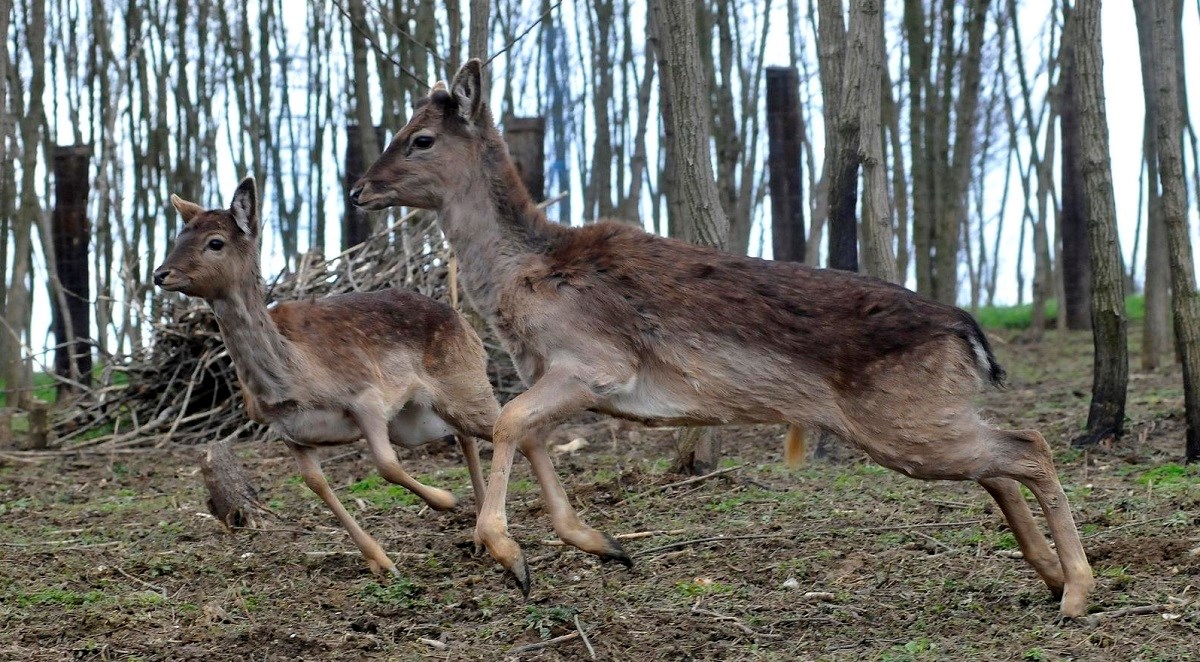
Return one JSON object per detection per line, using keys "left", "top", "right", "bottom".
{"left": 350, "top": 59, "right": 496, "bottom": 210}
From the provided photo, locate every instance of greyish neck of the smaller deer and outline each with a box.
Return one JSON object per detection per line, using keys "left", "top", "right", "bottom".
{"left": 209, "top": 281, "right": 293, "bottom": 404}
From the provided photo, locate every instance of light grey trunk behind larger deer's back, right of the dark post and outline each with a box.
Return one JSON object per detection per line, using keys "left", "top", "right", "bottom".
{"left": 842, "top": 0, "right": 899, "bottom": 283}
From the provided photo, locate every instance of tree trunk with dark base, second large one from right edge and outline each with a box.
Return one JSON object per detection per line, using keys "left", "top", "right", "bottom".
{"left": 1070, "top": 0, "right": 1128, "bottom": 444}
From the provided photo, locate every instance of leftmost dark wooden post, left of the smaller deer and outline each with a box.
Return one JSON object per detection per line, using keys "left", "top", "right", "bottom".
{"left": 50, "top": 145, "right": 91, "bottom": 398}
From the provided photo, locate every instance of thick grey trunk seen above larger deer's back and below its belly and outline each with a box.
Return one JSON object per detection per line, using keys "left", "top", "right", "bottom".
{"left": 650, "top": 0, "right": 730, "bottom": 474}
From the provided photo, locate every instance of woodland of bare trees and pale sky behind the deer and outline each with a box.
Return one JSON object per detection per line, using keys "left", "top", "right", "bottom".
{"left": 0, "top": 0, "right": 1200, "bottom": 452}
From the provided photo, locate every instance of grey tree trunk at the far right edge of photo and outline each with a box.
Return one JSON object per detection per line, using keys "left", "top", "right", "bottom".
{"left": 1152, "top": 0, "right": 1200, "bottom": 462}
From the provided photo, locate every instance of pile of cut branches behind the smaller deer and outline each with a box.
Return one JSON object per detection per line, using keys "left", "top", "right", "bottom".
{"left": 55, "top": 212, "right": 521, "bottom": 449}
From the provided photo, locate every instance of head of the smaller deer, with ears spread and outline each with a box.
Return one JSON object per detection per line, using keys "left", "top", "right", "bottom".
{"left": 154, "top": 177, "right": 258, "bottom": 300}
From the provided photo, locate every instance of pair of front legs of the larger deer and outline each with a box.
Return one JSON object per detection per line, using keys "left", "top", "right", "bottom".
{"left": 475, "top": 368, "right": 630, "bottom": 595}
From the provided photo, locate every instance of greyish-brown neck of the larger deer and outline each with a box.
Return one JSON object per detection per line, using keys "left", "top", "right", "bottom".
{"left": 440, "top": 139, "right": 560, "bottom": 320}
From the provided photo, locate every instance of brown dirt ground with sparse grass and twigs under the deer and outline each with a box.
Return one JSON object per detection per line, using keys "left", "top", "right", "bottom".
{"left": 0, "top": 333, "right": 1200, "bottom": 661}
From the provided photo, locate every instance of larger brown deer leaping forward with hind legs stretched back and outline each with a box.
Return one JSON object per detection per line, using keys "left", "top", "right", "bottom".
{"left": 352, "top": 60, "right": 1093, "bottom": 616}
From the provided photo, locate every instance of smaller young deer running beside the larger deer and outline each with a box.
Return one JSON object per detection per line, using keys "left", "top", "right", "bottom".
{"left": 154, "top": 177, "right": 499, "bottom": 573}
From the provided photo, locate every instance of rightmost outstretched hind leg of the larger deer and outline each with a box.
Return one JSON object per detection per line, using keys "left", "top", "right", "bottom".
{"left": 991, "top": 431, "right": 1094, "bottom": 618}
